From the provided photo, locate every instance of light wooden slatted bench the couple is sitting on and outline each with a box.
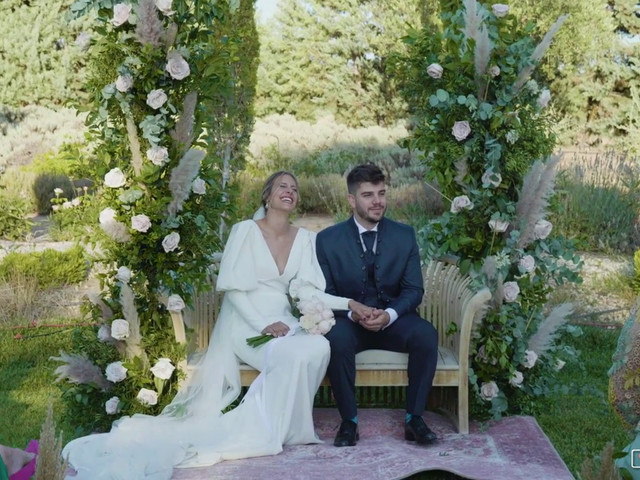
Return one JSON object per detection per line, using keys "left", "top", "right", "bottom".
{"left": 172, "top": 260, "right": 491, "bottom": 434}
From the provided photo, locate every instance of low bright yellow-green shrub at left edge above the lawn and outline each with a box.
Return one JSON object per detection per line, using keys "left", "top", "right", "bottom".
{"left": 0, "top": 245, "right": 89, "bottom": 289}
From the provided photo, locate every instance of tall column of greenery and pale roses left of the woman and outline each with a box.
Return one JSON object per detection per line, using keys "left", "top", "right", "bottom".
{"left": 54, "top": 0, "right": 257, "bottom": 431}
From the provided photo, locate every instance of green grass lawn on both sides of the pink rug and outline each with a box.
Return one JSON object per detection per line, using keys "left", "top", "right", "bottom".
{"left": 0, "top": 320, "right": 630, "bottom": 480}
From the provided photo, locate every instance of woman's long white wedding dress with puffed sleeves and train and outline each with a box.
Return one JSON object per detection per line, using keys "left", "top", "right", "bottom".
{"left": 63, "top": 220, "right": 348, "bottom": 480}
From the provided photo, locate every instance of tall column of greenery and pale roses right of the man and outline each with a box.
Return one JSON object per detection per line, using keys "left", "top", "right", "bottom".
{"left": 394, "top": 1, "right": 581, "bottom": 418}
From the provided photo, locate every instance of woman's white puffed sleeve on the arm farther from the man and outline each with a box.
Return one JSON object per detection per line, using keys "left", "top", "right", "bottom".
{"left": 216, "top": 220, "right": 264, "bottom": 332}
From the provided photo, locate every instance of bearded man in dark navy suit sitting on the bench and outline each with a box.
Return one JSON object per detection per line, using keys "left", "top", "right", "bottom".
{"left": 316, "top": 164, "right": 438, "bottom": 447}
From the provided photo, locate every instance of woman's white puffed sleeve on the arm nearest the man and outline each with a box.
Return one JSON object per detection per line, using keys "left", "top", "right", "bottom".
{"left": 289, "top": 230, "right": 350, "bottom": 310}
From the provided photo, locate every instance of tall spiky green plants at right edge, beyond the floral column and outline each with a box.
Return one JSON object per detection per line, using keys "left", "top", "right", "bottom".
{"left": 551, "top": 152, "right": 640, "bottom": 253}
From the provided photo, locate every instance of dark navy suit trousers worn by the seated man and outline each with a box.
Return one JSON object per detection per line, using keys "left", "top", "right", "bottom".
{"left": 326, "top": 312, "right": 438, "bottom": 420}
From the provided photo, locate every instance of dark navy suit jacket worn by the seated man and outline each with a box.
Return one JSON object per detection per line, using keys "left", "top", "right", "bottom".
{"left": 316, "top": 217, "right": 424, "bottom": 317}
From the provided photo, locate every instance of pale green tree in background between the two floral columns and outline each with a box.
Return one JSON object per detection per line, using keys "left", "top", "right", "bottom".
{"left": 256, "top": 0, "right": 419, "bottom": 126}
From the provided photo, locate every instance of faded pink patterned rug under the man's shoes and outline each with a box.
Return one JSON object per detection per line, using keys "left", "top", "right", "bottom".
{"left": 173, "top": 408, "right": 574, "bottom": 480}
